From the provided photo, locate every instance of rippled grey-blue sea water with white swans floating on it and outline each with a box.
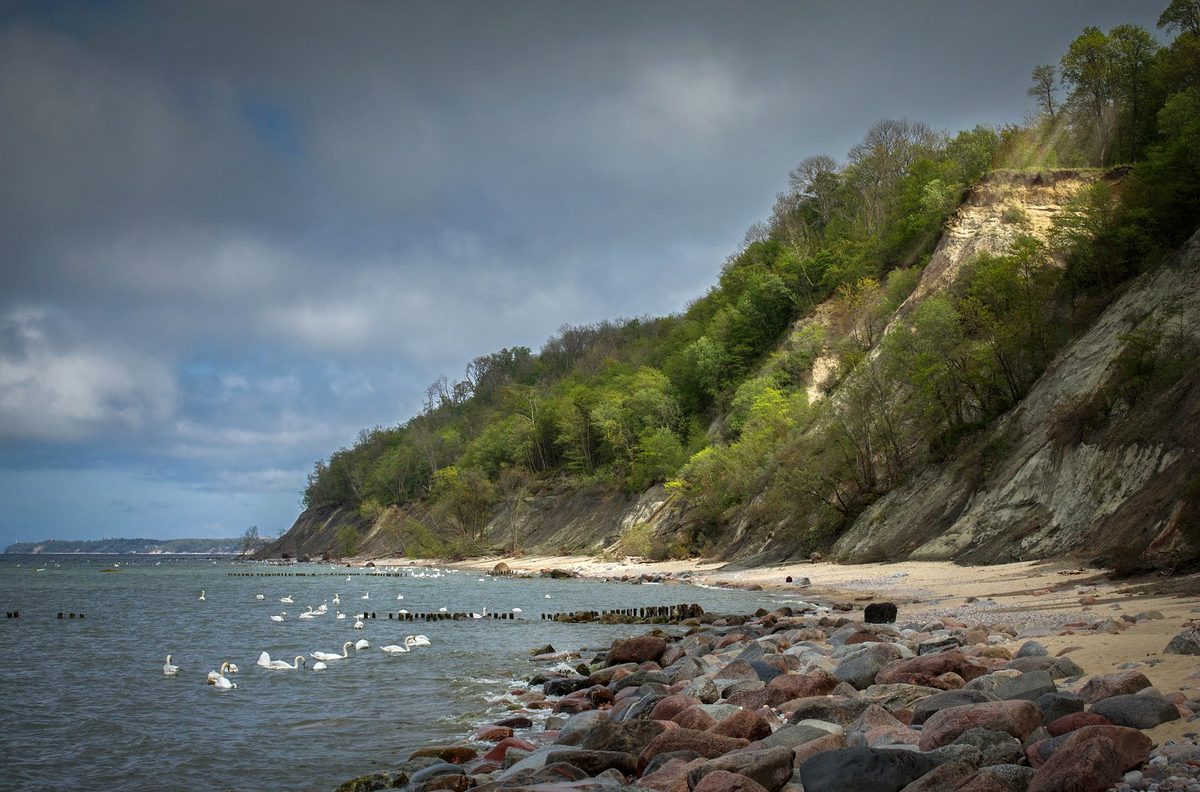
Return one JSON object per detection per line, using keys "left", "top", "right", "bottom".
{"left": 0, "top": 556, "right": 806, "bottom": 791}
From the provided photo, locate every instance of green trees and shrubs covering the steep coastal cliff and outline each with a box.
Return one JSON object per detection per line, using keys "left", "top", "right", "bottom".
{"left": 290, "top": 0, "right": 1200, "bottom": 564}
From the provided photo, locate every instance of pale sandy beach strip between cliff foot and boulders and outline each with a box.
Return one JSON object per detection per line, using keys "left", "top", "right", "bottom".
{"left": 376, "top": 556, "right": 1200, "bottom": 743}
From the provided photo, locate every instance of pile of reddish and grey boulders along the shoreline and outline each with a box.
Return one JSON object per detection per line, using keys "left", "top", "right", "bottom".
{"left": 338, "top": 607, "right": 1200, "bottom": 792}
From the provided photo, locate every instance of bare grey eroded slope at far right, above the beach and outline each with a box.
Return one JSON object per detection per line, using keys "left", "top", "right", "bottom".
{"left": 834, "top": 233, "right": 1200, "bottom": 565}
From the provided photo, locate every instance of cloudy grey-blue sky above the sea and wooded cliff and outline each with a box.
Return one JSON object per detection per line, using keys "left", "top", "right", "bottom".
{"left": 0, "top": 0, "right": 1165, "bottom": 546}
